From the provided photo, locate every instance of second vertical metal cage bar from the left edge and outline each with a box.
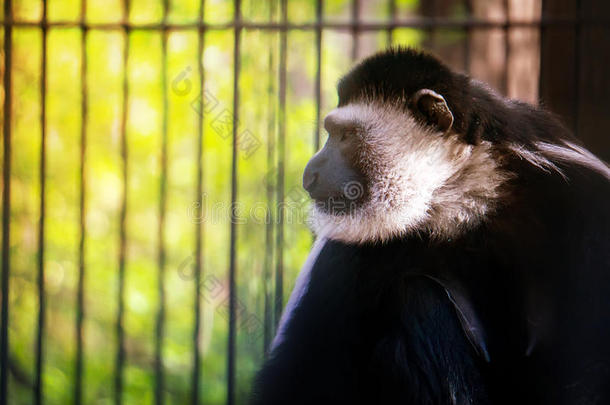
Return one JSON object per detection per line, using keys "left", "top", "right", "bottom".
{"left": 34, "top": 0, "right": 47, "bottom": 405}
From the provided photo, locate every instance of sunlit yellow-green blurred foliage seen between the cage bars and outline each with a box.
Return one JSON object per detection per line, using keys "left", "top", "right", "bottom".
{"left": 3, "top": 0, "right": 480, "bottom": 405}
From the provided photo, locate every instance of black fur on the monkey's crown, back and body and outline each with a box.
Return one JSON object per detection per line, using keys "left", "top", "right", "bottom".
{"left": 248, "top": 50, "right": 610, "bottom": 405}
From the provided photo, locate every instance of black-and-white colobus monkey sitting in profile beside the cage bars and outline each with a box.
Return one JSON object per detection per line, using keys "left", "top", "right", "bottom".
{"left": 248, "top": 49, "right": 610, "bottom": 405}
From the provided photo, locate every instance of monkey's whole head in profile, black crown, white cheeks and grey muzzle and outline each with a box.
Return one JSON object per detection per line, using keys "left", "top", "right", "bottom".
{"left": 303, "top": 49, "right": 508, "bottom": 243}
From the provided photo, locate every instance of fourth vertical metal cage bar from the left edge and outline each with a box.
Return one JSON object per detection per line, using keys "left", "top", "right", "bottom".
{"left": 114, "top": 0, "right": 130, "bottom": 405}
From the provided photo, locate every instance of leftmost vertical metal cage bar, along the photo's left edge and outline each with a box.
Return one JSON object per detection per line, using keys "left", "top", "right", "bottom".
{"left": 0, "top": 0, "right": 13, "bottom": 405}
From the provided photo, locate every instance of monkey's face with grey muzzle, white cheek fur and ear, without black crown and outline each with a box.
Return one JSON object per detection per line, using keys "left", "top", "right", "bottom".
{"left": 303, "top": 90, "right": 506, "bottom": 243}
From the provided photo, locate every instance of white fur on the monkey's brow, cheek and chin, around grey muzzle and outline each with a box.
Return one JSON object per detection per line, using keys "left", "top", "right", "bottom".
{"left": 310, "top": 103, "right": 510, "bottom": 243}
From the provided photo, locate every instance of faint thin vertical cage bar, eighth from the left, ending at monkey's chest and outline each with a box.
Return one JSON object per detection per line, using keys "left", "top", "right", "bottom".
{"left": 263, "top": 0, "right": 276, "bottom": 353}
